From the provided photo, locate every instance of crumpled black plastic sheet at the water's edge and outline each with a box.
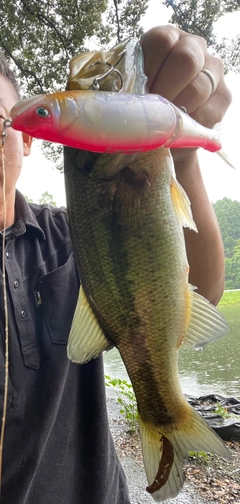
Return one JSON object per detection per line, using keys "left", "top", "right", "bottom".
{"left": 185, "top": 394, "right": 240, "bottom": 441}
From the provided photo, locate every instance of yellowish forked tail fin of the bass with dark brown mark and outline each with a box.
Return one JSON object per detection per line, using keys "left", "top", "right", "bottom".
{"left": 139, "top": 405, "right": 231, "bottom": 502}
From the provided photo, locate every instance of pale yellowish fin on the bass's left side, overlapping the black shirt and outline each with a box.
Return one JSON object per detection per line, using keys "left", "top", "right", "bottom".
{"left": 67, "top": 287, "right": 112, "bottom": 364}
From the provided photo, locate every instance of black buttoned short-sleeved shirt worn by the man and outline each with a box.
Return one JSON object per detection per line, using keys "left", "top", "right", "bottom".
{"left": 0, "top": 192, "right": 130, "bottom": 504}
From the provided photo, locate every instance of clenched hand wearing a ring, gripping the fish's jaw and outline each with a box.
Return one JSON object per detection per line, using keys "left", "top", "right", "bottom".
{"left": 141, "top": 25, "right": 231, "bottom": 128}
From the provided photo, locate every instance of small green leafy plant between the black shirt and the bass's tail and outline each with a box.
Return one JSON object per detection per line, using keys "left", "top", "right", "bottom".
{"left": 105, "top": 375, "right": 138, "bottom": 434}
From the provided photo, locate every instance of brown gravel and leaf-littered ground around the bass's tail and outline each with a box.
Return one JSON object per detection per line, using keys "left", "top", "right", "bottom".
{"left": 107, "top": 398, "right": 240, "bottom": 504}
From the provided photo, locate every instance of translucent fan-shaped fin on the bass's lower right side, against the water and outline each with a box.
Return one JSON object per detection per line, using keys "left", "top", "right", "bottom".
{"left": 183, "top": 285, "right": 229, "bottom": 349}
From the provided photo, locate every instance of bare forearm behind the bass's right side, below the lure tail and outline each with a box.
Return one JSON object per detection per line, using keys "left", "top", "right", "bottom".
{"left": 175, "top": 152, "right": 225, "bottom": 305}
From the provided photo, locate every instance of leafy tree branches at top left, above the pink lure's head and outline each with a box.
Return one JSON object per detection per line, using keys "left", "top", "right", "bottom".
{"left": 0, "top": 0, "right": 148, "bottom": 95}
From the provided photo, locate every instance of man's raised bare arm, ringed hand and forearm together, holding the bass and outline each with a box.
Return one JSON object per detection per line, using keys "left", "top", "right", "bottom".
{"left": 142, "top": 25, "right": 231, "bottom": 304}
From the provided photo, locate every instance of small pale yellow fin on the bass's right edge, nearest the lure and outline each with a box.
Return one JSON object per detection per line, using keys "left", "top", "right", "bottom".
{"left": 170, "top": 177, "right": 197, "bottom": 233}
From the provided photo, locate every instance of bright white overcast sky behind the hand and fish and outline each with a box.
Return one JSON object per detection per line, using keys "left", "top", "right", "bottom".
{"left": 17, "top": 0, "right": 240, "bottom": 206}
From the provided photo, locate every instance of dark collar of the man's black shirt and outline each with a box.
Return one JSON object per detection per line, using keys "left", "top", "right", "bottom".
{"left": 12, "top": 190, "right": 46, "bottom": 240}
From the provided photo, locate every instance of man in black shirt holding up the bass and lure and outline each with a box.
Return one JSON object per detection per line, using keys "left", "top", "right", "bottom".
{"left": 0, "top": 25, "right": 231, "bottom": 504}
